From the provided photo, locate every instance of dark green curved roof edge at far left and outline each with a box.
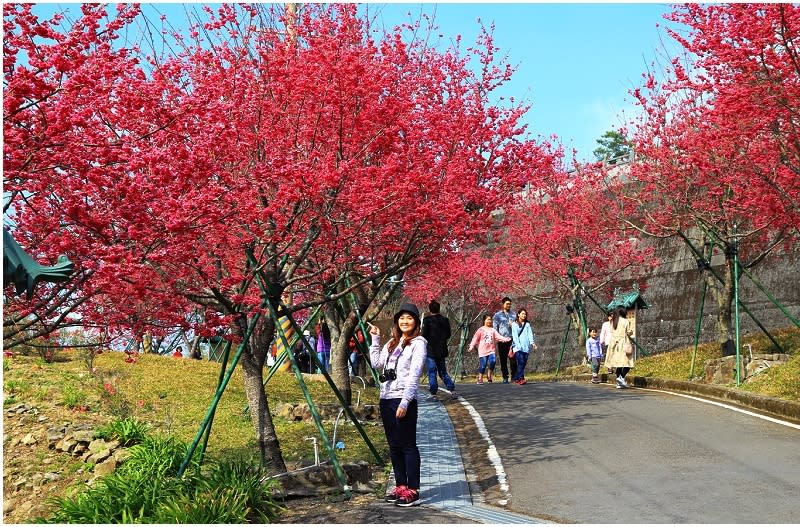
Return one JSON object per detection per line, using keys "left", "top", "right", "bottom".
{"left": 3, "top": 227, "right": 74, "bottom": 300}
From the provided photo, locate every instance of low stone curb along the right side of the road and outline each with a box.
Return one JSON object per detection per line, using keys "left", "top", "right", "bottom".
{"left": 555, "top": 374, "right": 800, "bottom": 424}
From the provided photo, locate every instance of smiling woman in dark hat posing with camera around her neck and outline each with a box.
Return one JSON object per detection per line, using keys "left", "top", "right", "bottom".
{"left": 368, "top": 304, "right": 427, "bottom": 507}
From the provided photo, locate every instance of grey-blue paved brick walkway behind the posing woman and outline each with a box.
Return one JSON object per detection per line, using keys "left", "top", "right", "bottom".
{"left": 389, "top": 390, "right": 549, "bottom": 524}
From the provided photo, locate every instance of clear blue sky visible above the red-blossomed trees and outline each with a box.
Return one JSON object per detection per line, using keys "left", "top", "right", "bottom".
{"left": 29, "top": 2, "right": 675, "bottom": 161}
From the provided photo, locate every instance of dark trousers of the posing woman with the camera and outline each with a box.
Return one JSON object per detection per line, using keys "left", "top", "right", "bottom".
{"left": 380, "top": 399, "right": 422, "bottom": 490}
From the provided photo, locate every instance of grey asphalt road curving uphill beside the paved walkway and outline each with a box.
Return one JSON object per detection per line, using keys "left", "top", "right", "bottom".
{"left": 458, "top": 382, "right": 800, "bottom": 523}
